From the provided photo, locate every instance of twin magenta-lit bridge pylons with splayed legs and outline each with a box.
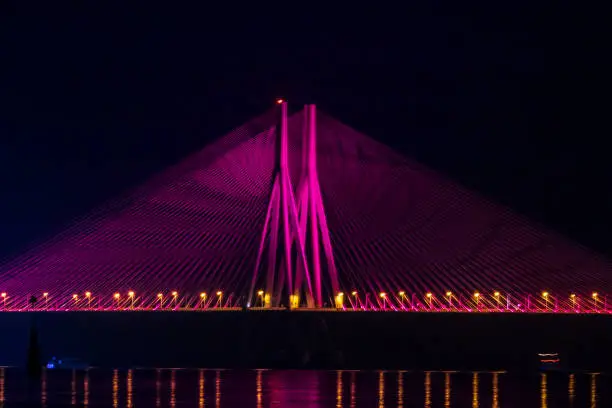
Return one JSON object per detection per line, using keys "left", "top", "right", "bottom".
{"left": 248, "top": 100, "right": 338, "bottom": 308}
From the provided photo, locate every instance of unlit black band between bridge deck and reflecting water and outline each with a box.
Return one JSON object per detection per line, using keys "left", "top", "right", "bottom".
{"left": 0, "top": 310, "right": 612, "bottom": 371}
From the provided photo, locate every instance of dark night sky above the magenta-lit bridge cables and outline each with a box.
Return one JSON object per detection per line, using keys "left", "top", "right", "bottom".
{"left": 0, "top": 0, "right": 612, "bottom": 256}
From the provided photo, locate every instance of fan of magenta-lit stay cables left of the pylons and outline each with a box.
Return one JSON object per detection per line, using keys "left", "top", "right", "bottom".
{"left": 0, "top": 113, "right": 274, "bottom": 308}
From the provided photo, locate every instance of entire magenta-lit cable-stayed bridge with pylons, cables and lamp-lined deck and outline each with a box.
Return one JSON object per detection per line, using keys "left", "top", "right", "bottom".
{"left": 0, "top": 100, "right": 612, "bottom": 313}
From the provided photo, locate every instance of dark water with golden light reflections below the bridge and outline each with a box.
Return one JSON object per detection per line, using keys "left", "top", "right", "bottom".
{"left": 0, "top": 367, "right": 612, "bottom": 408}
